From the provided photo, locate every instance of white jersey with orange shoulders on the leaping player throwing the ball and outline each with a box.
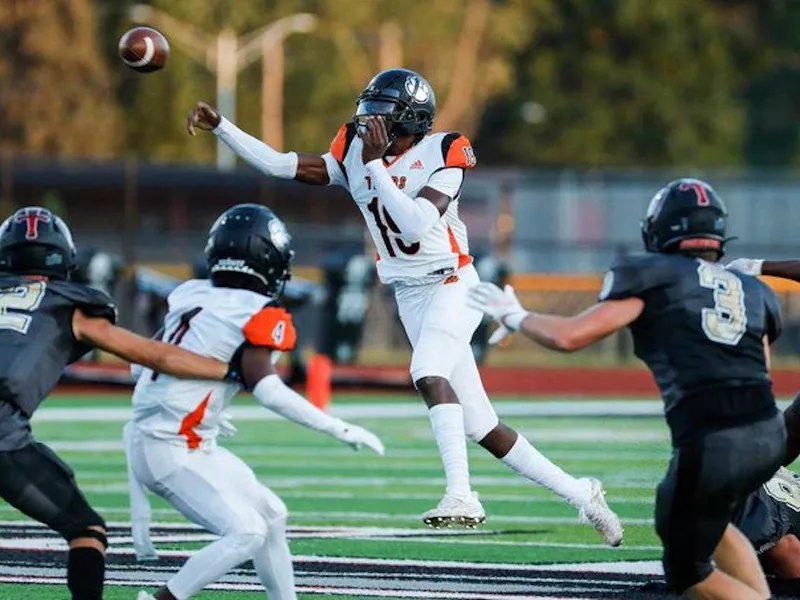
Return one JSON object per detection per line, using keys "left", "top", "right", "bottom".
{"left": 323, "top": 123, "right": 476, "bottom": 284}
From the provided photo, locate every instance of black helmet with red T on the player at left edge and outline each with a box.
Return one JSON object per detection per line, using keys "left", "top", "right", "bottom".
{"left": 0, "top": 206, "right": 75, "bottom": 281}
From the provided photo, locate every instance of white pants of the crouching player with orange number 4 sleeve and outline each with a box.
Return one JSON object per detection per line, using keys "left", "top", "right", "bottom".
{"left": 126, "top": 426, "right": 297, "bottom": 600}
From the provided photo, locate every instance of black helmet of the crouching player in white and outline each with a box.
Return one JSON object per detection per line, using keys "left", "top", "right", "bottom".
{"left": 205, "top": 204, "right": 294, "bottom": 297}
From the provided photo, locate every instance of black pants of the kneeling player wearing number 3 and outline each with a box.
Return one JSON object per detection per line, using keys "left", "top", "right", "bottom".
{"left": 656, "top": 411, "right": 786, "bottom": 594}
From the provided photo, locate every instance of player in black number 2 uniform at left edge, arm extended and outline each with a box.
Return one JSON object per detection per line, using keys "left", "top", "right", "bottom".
{"left": 0, "top": 207, "right": 241, "bottom": 600}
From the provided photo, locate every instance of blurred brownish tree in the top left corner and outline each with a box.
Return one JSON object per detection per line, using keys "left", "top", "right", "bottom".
{"left": 0, "top": 0, "right": 122, "bottom": 157}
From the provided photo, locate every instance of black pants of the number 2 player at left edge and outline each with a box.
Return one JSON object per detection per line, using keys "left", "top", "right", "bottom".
{"left": 0, "top": 442, "right": 105, "bottom": 541}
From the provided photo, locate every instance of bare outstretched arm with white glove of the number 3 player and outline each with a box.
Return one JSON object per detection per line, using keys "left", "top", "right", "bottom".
{"left": 469, "top": 283, "right": 644, "bottom": 352}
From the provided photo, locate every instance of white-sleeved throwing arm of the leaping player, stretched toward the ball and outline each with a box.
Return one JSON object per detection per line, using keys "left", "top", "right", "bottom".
{"left": 186, "top": 102, "right": 330, "bottom": 185}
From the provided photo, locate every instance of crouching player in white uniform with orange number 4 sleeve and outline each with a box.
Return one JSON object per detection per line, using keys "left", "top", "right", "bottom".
{"left": 125, "top": 204, "right": 383, "bottom": 600}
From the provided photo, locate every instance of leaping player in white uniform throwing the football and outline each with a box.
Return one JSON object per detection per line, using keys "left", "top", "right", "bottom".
{"left": 187, "top": 69, "right": 622, "bottom": 545}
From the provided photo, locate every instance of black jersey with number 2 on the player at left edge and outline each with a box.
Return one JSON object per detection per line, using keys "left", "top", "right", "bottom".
{"left": 0, "top": 277, "right": 116, "bottom": 417}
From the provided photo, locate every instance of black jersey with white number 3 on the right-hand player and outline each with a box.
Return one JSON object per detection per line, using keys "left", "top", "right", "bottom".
{"left": 600, "top": 253, "right": 781, "bottom": 415}
